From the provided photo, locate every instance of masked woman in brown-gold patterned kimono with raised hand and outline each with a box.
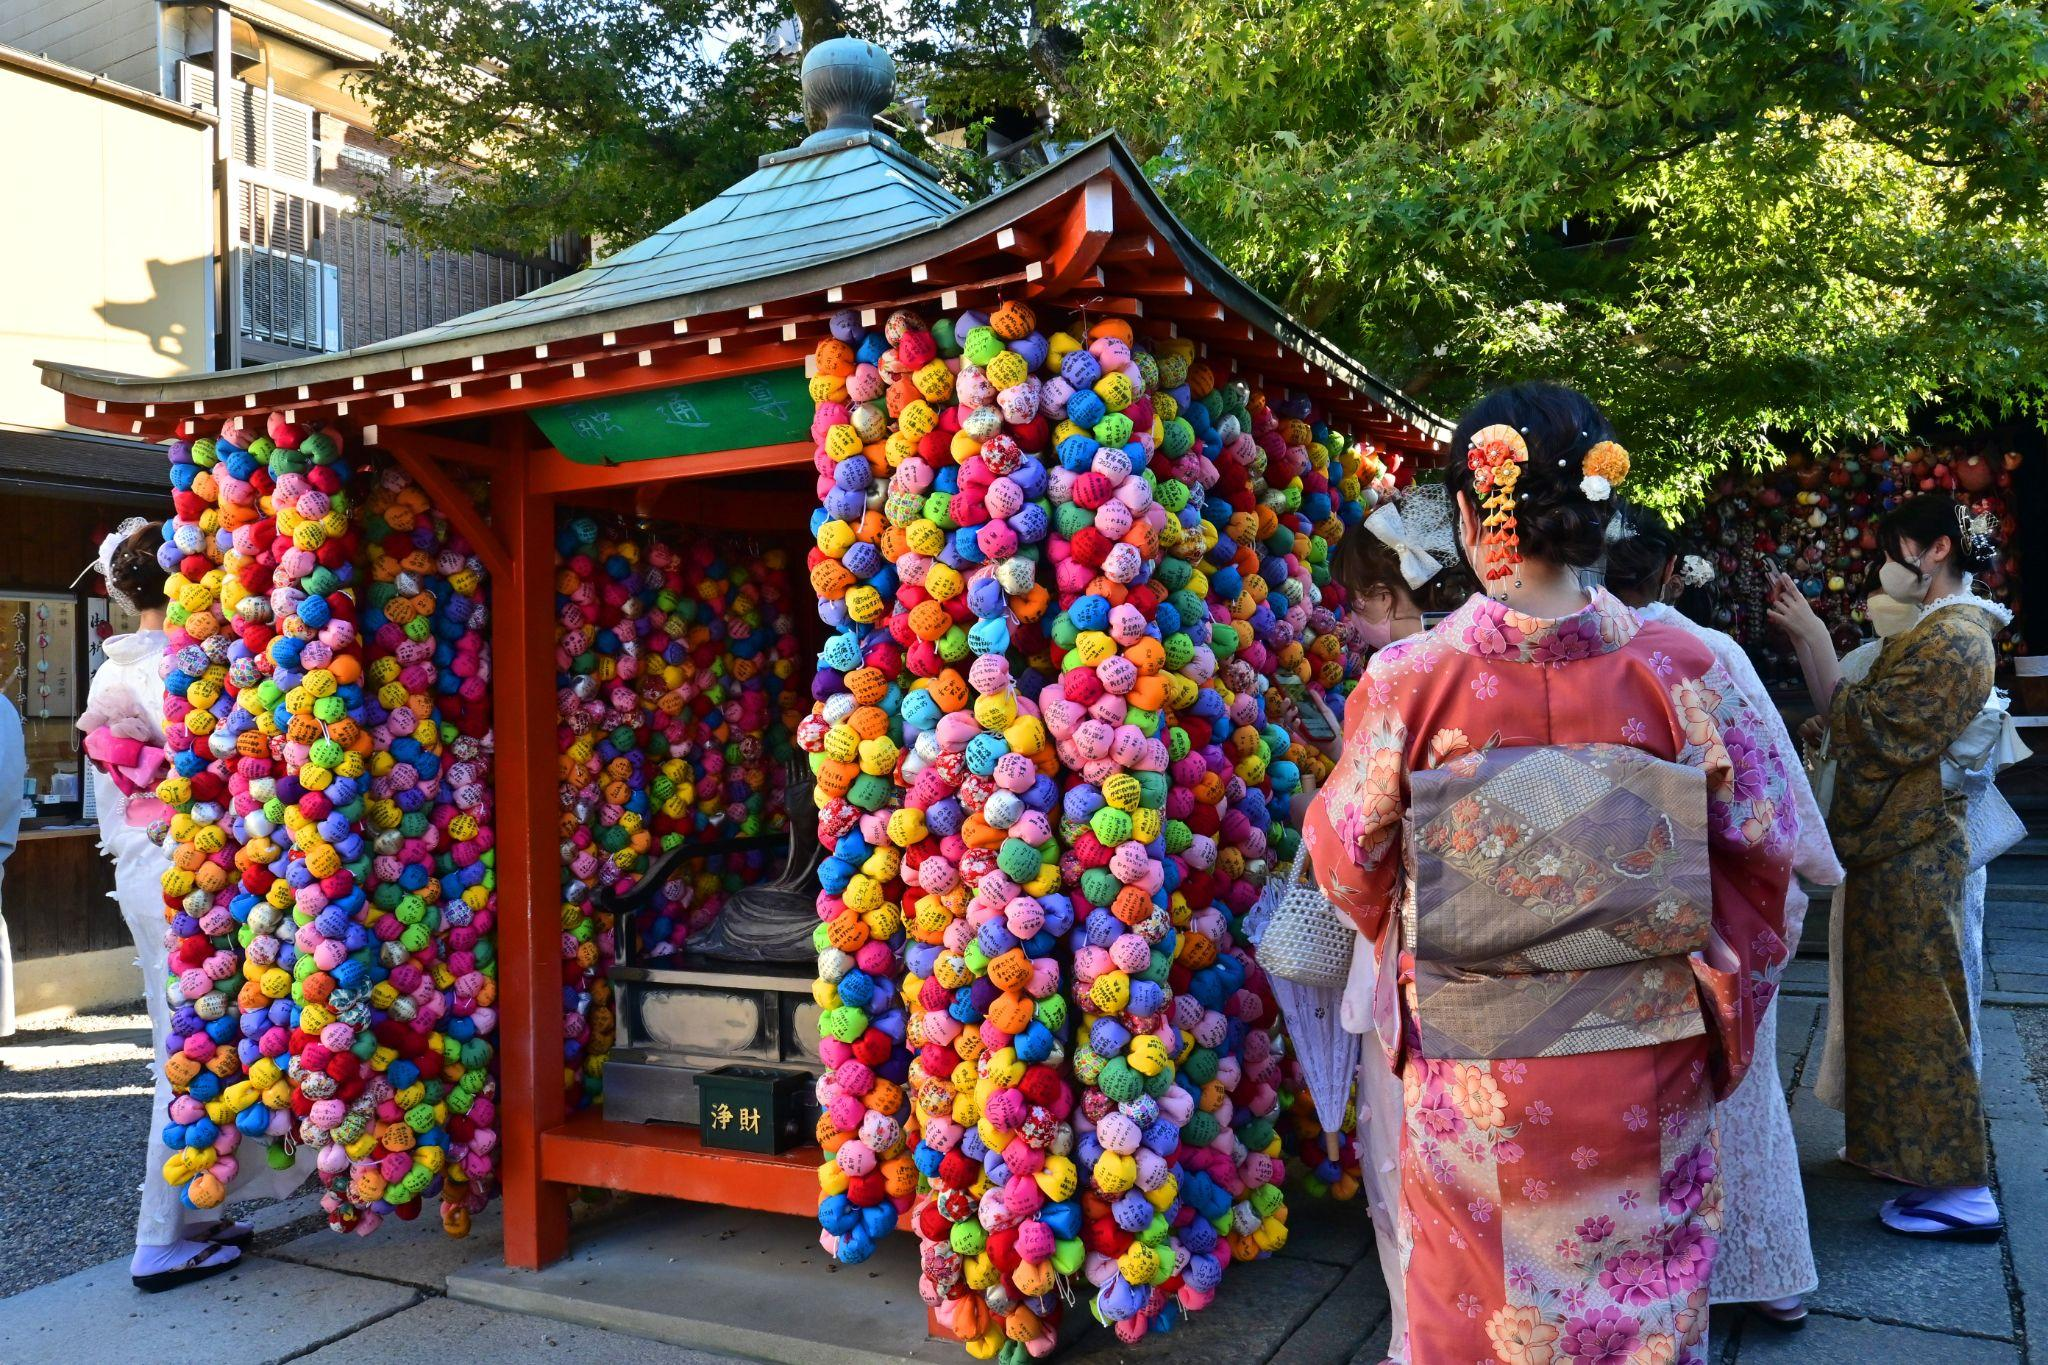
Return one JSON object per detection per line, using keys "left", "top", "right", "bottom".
{"left": 1769, "top": 493, "right": 2003, "bottom": 1240}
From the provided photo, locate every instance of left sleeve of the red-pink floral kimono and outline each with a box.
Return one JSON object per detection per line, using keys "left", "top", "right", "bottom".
{"left": 1303, "top": 647, "right": 1407, "bottom": 941}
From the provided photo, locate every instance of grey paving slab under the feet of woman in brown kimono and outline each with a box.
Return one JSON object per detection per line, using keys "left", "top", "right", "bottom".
{"left": 1806, "top": 1177, "right": 2013, "bottom": 1334}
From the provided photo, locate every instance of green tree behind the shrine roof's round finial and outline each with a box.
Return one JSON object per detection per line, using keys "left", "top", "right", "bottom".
{"left": 354, "top": 0, "right": 1053, "bottom": 263}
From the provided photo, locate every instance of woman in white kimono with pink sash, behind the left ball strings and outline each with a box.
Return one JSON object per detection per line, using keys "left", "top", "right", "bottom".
{"left": 78, "top": 518, "right": 311, "bottom": 1293}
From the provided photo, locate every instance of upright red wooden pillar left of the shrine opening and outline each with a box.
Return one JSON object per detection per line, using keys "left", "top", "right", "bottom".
{"left": 492, "top": 415, "right": 569, "bottom": 1269}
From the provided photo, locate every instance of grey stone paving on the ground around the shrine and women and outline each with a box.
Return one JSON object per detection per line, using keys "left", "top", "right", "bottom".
{"left": 0, "top": 857, "right": 2048, "bottom": 1365}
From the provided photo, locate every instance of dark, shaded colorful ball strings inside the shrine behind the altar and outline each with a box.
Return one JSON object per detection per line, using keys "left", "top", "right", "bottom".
{"left": 555, "top": 516, "right": 803, "bottom": 1109}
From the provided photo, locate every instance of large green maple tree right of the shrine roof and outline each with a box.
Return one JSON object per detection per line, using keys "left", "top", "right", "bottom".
{"left": 1061, "top": 0, "right": 2048, "bottom": 505}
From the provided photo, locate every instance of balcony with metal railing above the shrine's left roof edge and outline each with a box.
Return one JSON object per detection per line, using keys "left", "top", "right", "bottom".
{"left": 227, "top": 164, "right": 575, "bottom": 352}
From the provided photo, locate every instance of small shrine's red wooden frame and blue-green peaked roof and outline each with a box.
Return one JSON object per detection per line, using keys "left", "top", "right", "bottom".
{"left": 43, "top": 42, "right": 1448, "bottom": 1267}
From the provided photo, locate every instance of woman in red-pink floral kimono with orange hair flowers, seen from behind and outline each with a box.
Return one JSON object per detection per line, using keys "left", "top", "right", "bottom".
{"left": 1307, "top": 385, "right": 1792, "bottom": 1365}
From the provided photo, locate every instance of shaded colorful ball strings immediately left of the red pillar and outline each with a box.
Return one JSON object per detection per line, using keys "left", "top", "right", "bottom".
{"left": 346, "top": 469, "right": 496, "bottom": 1234}
